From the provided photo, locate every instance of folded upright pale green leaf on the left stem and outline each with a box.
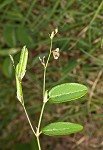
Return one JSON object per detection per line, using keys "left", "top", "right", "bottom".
{"left": 16, "top": 46, "right": 28, "bottom": 80}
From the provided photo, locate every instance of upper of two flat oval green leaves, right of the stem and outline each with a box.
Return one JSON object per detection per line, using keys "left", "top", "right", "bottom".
{"left": 49, "top": 83, "right": 88, "bottom": 103}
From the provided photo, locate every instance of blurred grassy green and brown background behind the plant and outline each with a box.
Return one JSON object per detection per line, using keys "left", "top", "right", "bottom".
{"left": 0, "top": 0, "right": 103, "bottom": 150}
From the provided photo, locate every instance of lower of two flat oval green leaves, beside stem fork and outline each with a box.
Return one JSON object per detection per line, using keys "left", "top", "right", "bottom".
{"left": 42, "top": 122, "right": 83, "bottom": 136}
